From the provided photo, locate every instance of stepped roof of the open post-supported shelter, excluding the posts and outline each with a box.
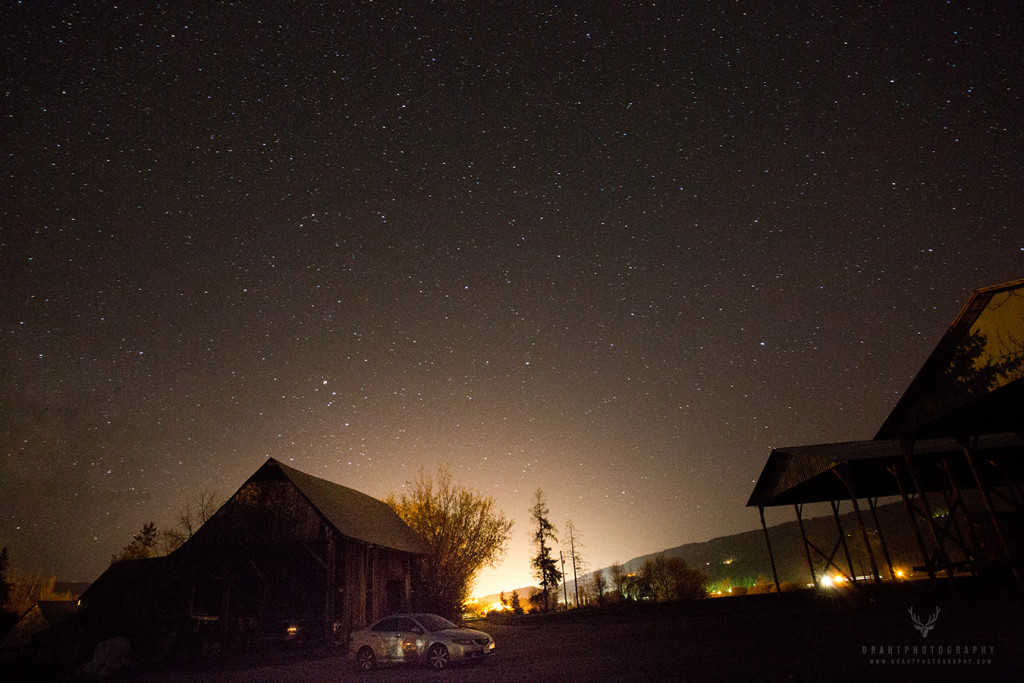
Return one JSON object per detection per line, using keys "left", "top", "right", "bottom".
{"left": 748, "top": 280, "right": 1024, "bottom": 507}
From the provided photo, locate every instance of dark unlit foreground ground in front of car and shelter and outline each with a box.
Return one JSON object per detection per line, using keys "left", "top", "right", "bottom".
{"left": 116, "top": 584, "right": 1024, "bottom": 682}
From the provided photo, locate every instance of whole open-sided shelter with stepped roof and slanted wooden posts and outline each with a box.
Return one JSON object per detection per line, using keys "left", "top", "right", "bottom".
{"left": 748, "top": 281, "right": 1024, "bottom": 584}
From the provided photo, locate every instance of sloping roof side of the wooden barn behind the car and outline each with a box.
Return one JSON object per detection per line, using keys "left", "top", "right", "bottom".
{"left": 266, "top": 458, "right": 429, "bottom": 554}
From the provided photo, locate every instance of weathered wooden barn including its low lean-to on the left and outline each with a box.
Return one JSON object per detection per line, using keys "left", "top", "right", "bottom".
{"left": 82, "top": 458, "right": 427, "bottom": 649}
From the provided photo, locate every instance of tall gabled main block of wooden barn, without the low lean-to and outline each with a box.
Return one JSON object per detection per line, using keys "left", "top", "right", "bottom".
{"left": 175, "top": 459, "right": 427, "bottom": 642}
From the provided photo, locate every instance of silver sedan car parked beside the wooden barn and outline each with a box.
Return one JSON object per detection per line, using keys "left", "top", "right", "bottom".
{"left": 348, "top": 614, "right": 495, "bottom": 671}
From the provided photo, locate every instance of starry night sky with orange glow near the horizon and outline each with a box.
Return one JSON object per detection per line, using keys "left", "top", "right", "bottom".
{"left": 0, "top": 1, "right": 1024, "bottom": 592}
